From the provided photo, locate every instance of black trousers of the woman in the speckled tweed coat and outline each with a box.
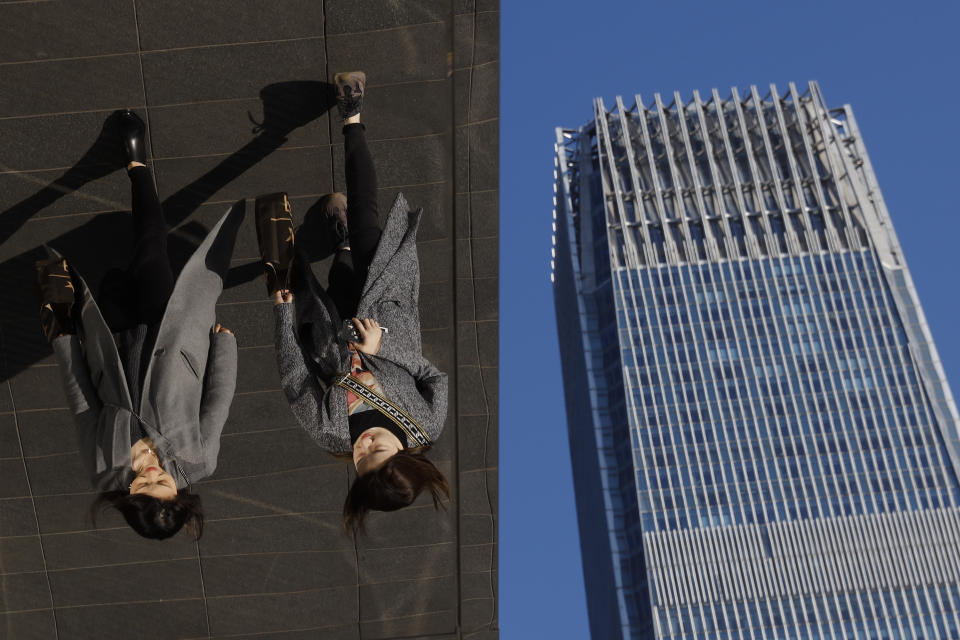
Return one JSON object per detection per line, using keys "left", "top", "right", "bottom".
{"left": 327, "top": 123, "right": 382, "bottom": 319}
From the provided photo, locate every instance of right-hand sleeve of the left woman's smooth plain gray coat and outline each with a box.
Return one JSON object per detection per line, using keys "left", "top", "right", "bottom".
{"left": 200, "top": 332, "right": 237, "bottom": 456}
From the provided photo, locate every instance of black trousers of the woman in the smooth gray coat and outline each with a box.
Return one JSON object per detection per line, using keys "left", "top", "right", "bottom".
{"left": 98, "top": 167, "right": 174, "bottom": 332}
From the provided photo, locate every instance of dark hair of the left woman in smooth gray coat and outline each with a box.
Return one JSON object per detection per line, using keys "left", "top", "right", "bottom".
{"left": 90, "top": 490, "right": 203, "bottom": 540}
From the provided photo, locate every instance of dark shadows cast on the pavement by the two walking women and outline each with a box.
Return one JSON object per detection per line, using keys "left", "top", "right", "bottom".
{"left": 0, "top": 81, "right": 336, "bottom": 381}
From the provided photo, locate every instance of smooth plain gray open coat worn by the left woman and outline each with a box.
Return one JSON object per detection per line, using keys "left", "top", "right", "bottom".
{"left": 53, "top": 202, "right": 243, "bottom": 491}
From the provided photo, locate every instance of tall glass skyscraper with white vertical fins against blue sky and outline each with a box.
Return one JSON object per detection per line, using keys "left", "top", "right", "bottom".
{"left": 551, "top": 83, "right": 960, "bottom": 640}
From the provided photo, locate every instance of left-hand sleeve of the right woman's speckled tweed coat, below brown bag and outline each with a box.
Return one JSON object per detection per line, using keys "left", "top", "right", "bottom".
{"left": 273, "top": 303, "right": 340, "bottom": 442}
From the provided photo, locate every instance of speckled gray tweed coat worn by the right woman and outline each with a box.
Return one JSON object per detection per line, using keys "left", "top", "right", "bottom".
{"left": 274, "top": 194, "right": 447, "bottom": 453}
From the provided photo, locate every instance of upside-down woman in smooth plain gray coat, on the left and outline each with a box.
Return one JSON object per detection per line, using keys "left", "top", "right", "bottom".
{"left": 37, "top": 111, "right": 243, "bottom": 539}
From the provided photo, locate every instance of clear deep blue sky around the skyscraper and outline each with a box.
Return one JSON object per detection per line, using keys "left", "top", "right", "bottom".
{"left": 499, "top": 0, "right": 960, "bottom": 640}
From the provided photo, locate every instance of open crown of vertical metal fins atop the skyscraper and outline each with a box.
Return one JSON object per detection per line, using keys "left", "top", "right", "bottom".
{"left": 594, "top": 83, "right": 865, "bottom": 268}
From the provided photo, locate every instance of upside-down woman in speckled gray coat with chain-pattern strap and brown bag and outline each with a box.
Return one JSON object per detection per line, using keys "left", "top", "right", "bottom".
{"left": 257, "top": 72, "right": 449, "bottom": 530}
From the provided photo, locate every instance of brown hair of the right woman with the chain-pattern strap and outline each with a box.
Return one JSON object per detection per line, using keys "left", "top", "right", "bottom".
{"left": 343, "top": 449, "right": 450, "bottom": 533}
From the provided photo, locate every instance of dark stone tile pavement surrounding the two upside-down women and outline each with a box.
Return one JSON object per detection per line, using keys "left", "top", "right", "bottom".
{"left": 0, "top": 0, "right": 499, "bottom": 639}
